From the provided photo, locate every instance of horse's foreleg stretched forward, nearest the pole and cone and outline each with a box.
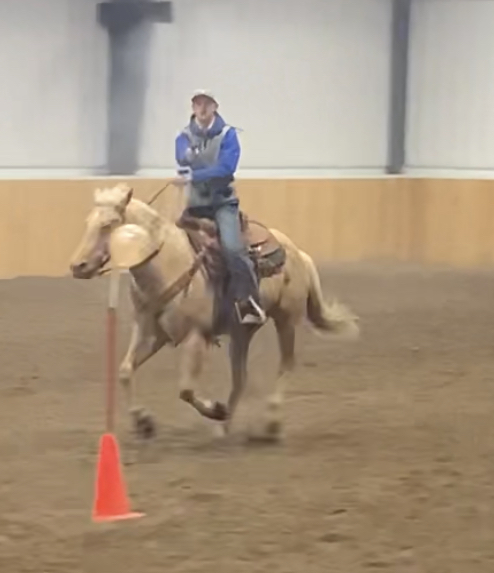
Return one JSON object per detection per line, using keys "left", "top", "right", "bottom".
{"left": 119, "top": 318, "right": 167, "bottom": 437}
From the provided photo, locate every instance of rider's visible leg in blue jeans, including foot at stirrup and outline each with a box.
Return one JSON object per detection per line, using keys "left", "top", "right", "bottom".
{"left": 215, "top": 201, "right": 266, "bottom": 324}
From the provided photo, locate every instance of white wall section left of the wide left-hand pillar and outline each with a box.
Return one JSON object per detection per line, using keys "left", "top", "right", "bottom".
{"left": 0, "top": 0, "right": 107, "bottom": 169}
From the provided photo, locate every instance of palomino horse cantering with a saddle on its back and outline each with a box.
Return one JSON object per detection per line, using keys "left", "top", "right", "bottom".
{"left": 71, "top": 184, "right": 359, "bottom": 437}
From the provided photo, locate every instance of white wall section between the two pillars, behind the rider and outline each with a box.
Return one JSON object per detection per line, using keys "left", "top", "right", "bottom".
{"left": 141, "top": 0, "right": 391, "bottom": 169}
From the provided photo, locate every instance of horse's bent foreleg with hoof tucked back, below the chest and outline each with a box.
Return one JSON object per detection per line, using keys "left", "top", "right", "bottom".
{"left": 179, "top": 330, "right": 227, "bottom": 420}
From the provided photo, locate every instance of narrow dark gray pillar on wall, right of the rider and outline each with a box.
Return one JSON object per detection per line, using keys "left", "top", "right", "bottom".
{"left": 386, "top": 0, "right": 411, "bottom": 174}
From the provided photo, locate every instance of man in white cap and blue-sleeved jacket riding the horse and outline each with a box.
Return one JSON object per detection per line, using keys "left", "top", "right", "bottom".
{"left": 175, "top": 90, "right": 266, "bottom": 324}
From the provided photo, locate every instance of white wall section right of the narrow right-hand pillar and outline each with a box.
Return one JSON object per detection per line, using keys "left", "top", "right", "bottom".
{"left": 406, "top": 0, "right": 494, "bottom": 169}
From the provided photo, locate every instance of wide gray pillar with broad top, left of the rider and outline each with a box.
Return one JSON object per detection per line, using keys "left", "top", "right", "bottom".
{"left": 98, "top": 0, "right": 172, "bottom": 175}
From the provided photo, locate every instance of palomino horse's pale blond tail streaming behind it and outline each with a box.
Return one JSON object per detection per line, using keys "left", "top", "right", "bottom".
{"left": 300, "top": 251, "right": 360, "bottom": 339}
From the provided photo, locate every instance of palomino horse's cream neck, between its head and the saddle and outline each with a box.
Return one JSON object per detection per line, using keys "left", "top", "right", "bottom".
{"left": 126, "top": 199, "right": 193, "bottom": 295}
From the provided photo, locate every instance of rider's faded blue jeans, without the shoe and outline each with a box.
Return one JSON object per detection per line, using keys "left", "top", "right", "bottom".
{"left": 182, "top": 201, "right": 260, "bottom": 303}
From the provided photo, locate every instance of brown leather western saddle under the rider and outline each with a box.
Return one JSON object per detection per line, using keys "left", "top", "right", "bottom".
{"left": 176, "top": 212, "right": 286, "bottom": 286}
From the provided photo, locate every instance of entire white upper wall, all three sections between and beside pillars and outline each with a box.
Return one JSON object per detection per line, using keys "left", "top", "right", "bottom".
{"left": 8, "top": 0, "right": 494, "bottom": 173}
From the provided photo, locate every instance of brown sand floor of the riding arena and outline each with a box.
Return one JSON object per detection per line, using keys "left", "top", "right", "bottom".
{"left": 0, "top": 265, "right": 494, "bottom": 573}
